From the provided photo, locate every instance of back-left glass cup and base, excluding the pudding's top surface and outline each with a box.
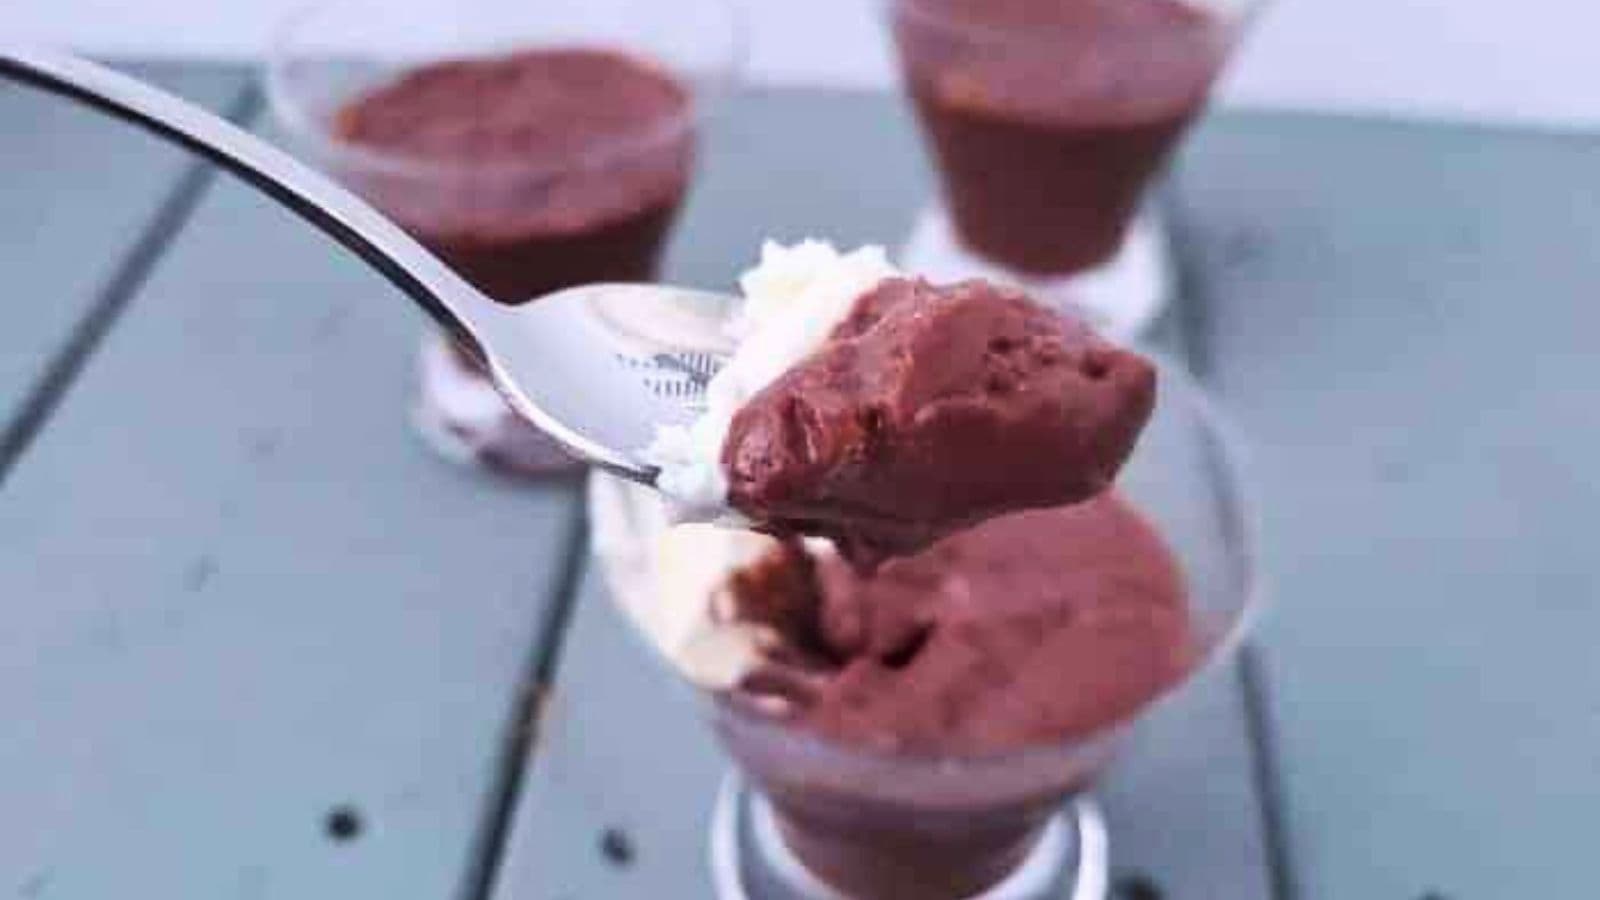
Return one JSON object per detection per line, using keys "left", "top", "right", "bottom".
{"left": 266, "top": 0, "right": 744, "bottom": 474}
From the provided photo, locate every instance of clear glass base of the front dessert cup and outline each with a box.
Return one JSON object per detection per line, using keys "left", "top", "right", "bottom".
{"left": 710, "top": 772, "right": 1109, "bottom": 900}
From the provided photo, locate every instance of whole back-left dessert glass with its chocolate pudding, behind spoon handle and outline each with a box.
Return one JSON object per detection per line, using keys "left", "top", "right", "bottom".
{"left": 267, "top": 0, "right": 742, "bottom": 474}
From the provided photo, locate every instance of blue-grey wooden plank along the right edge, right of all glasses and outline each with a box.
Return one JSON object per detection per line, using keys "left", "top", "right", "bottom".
{"left": 1179, "top": 117, "right": 1600, "bottom": 900}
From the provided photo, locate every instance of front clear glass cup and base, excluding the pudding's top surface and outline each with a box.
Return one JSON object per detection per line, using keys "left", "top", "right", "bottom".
{"left": 592, "top": 353, "right": 1258, "bottom": 900}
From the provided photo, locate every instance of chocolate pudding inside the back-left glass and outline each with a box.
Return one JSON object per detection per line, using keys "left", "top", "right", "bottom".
{"left": 334, "top": 48, "right": 693, "bottom": 303}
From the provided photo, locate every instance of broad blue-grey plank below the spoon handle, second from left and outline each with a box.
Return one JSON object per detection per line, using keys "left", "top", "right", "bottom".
{"left": 0, "top": 110, "right": 576, "bottom": 900}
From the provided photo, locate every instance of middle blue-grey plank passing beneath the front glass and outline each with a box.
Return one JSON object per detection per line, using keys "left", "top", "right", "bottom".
{"left": 494, "top": 91, "right": 1269, "bottom": 900}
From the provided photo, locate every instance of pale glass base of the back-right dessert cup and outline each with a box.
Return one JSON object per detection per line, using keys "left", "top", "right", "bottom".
{"left": 898, "top": 202, "right": 1173, "bottom": 343}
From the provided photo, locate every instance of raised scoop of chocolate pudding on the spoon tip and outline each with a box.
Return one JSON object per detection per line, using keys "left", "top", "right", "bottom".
{"left": 722, "top": 279, "right": 1155, "bottom": 569}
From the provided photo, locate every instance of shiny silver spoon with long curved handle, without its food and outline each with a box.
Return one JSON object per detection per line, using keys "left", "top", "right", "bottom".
{"left": 0, "top": 42, "right": 731, "bottom": 487}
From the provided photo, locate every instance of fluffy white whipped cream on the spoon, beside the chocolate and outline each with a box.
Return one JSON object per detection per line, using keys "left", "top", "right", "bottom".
{"left": 645, "top": 240, "right": 901, "bottom": 519}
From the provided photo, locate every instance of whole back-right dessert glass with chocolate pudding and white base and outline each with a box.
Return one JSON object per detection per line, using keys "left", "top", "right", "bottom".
{"left": 885, "top": 0, "right": 1254, "bottom": 340}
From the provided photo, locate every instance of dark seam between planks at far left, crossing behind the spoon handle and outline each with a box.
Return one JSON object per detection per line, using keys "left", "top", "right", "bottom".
{"left": 0, "top": 86, "right": 261, "bottom": 487}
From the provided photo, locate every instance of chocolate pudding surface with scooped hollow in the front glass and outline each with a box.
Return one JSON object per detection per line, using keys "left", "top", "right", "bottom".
{"left": 733, "top": 492, "right": 1190, "bottom": 756}
